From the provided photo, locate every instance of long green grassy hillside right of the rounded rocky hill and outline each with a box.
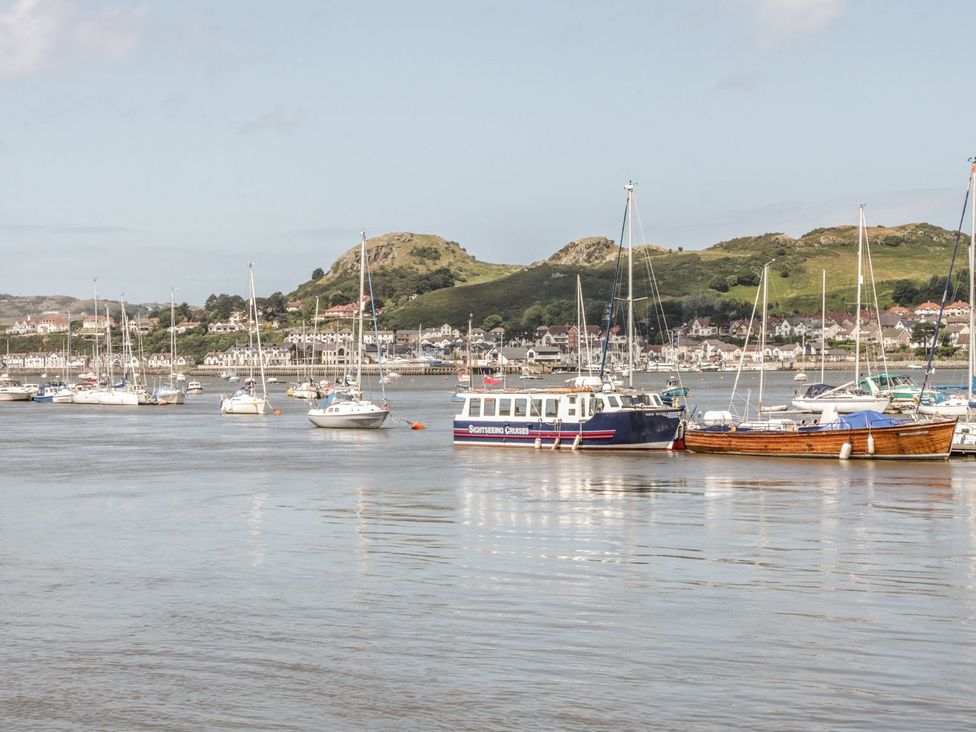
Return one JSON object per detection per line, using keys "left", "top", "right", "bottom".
{"left": 385, "top": 224, "right": 961, "bottom": 328}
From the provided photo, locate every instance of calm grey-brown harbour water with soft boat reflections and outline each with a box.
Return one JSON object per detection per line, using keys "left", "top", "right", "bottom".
{"left": 0, "top": 374, "right": 976, "bottom": 730}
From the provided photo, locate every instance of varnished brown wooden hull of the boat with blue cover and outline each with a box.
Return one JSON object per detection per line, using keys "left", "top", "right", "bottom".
{"left": 685, "top": 419, "right": 956, "bottom": 460}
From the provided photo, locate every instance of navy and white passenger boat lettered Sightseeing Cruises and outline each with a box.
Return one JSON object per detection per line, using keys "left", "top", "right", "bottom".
{"left": 454, "top": 387, "right": 684, "bottom": 450}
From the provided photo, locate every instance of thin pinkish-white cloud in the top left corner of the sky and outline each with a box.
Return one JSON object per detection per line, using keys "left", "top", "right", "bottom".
{"left": 0, "top": 0, "right": 149, "bottom": 79}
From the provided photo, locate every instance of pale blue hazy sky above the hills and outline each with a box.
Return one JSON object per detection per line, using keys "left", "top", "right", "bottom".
{"left": 0, "top": 0, "right": 976, "bottom": 304}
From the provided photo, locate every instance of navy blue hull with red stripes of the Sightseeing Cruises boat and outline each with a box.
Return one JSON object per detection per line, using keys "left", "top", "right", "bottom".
{"left": 454, "top": 409, "right": 682, "bottom": 450}
